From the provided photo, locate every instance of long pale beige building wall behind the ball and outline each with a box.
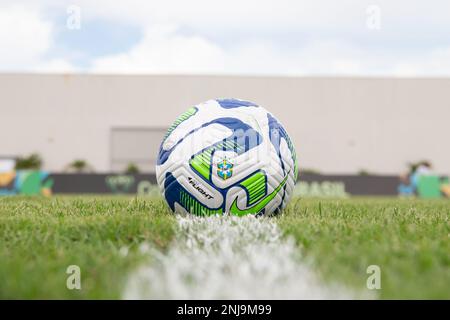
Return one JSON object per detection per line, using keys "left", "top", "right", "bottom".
{"left": 0, "top": 74, "right": 450, "bottom": 174}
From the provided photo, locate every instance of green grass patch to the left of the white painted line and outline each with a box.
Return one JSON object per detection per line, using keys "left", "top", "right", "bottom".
{"left": 0, "top": 197, "right": 174, "bottom": 299}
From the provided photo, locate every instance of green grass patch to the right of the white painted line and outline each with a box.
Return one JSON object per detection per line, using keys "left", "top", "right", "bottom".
{"left": 279, "top": 199, "right": 450, "bottom": 299}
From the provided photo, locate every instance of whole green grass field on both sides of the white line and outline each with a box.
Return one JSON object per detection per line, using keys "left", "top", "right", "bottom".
{"left": 0, "top": 196, "right": 450, "bottom": 299}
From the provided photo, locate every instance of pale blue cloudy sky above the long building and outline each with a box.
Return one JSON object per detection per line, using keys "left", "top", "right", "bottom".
{"left": 0, "top": 0, "right": 450, "bottom": 77}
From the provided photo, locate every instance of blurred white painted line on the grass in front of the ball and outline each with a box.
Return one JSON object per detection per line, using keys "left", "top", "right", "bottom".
{"left": 123, "top": 216, "right": 355, "bottom": 299}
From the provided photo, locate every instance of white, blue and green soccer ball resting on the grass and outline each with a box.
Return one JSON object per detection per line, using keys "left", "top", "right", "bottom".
{"left": 156, "top": 99, "right": 298, "bottom": 216}
